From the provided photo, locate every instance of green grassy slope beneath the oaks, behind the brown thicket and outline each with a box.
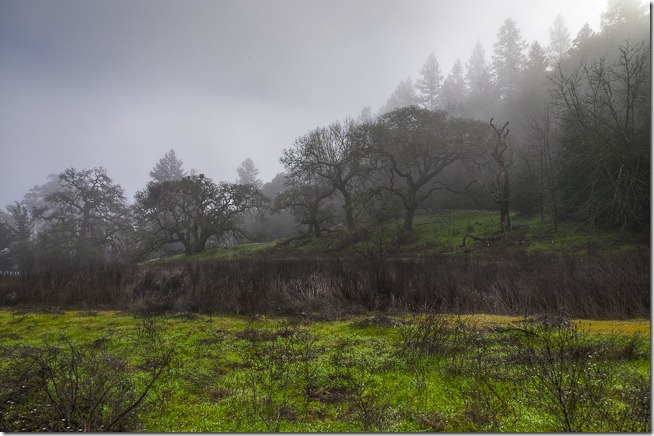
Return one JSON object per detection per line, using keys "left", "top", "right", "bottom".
{"left": 149, "top": 210, "right": 643, "bottom": 263}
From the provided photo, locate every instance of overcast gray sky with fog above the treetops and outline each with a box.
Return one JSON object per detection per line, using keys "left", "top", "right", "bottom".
{"left": 0, "top": 0, "right": 607, "bottom": 207}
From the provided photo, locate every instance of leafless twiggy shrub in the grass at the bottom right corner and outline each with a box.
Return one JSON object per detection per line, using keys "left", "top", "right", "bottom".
{"left": 514, "top": 322, "right": 650, "bottom": 432}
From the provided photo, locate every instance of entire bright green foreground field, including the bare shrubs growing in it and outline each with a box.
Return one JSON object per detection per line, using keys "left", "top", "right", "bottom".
{"left": 0, "top": 310, "right": 651, "bottom": 432}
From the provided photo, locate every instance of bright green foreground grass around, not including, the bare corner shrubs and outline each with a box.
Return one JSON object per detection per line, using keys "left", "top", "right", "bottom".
{"left": 0, "top": 310, "right": 650, "bottom": 432}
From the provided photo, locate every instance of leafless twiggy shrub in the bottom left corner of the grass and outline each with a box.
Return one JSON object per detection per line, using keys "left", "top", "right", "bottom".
{"left": 0, "top": 338, "right": 172, "bottom": 432}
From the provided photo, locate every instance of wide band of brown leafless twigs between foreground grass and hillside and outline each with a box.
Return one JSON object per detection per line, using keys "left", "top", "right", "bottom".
{"left": 0, "top": 250, "right": 650, "bottom": 319}
